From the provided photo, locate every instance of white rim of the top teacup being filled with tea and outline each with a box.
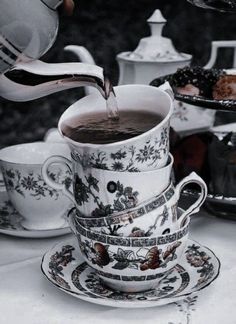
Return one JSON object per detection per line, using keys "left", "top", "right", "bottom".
{"left": 58, "top": 84, "right": 174, "bottom": 149}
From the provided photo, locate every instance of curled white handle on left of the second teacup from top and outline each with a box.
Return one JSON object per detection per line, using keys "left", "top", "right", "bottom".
{"left": 42, "top": 155, "right": 75, "bottom": 204}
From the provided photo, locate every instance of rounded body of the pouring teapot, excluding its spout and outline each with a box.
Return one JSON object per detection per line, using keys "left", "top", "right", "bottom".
{"left": 0, "top": 0, "right": 62, "bottom": 73}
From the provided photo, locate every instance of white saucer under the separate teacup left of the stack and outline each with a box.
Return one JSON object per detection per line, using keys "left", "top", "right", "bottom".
{"left": 0, "top": 190, "right": 71, "bottom": 238}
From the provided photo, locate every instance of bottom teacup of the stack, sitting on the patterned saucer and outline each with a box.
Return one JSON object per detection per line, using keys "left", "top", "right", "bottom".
{"left": 69, "top": 210, "right": 189, "bottom": 292}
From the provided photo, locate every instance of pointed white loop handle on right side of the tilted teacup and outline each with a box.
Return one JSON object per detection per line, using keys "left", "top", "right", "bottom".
{"left": 175, "top": 172, "right": 207, "bottom": 226}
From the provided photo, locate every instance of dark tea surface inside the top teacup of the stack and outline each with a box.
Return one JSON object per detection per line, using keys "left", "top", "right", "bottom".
{"left": 61, "top": 109, "right": 163, "bottom": 144}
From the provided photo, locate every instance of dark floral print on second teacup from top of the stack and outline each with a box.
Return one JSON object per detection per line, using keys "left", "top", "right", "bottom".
{"left": 74, "top": 173, "right": 139, "bottom": 217}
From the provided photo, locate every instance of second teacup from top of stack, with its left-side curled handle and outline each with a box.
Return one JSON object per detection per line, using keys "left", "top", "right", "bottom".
{"left": 42, "top": 155, "right": 173, "bottom": 217}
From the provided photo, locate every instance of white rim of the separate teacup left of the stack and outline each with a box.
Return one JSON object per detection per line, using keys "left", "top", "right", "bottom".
{"left": 0, "top": 141, "right": 70, "bottom": 166}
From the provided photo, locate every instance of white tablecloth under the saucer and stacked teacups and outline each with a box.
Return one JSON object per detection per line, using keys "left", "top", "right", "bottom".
{"left": 0, "top": 212, "right": 236, "bottom": 324}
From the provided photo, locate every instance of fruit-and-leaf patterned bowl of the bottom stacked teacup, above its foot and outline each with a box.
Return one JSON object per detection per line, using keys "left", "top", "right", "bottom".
{"left": 69, "top": 213, "right": 189, "bottom": 275}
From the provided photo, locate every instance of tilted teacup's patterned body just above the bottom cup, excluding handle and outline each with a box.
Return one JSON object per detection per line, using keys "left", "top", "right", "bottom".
{"left": 75, "top": 184, "right": 178, "bottom": 237}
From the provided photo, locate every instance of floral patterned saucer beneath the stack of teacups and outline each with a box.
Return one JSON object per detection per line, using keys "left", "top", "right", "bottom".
{"left": 43, "top": 240, "right": 220, "bottom": 303}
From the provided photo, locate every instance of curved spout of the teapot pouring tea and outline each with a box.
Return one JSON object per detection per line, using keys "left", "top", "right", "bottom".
{"left": 0, "top": 60, "right": 111, "bottom": 101}
